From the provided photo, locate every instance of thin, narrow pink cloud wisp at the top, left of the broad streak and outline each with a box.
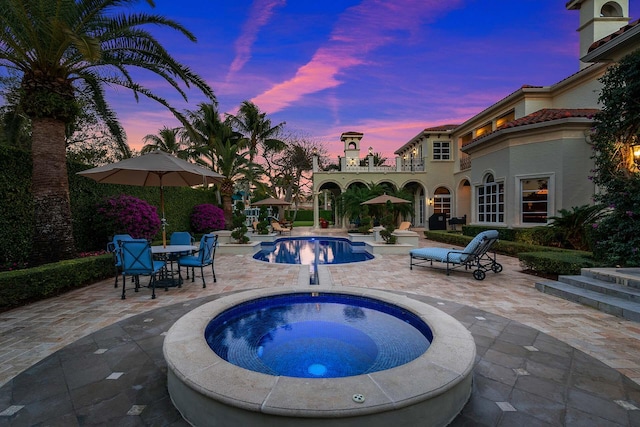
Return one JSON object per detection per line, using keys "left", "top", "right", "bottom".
{"left": 227, "top": 0, "right": 286, "bottom": 76}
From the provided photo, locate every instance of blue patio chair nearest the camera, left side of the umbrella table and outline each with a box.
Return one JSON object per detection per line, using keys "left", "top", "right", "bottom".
{"left": 119, "top": 239, "right": 166, "bottom": 299}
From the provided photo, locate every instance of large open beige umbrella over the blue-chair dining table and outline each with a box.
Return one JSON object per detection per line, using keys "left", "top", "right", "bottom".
{"left": 78, "top": 150, "right": 224, "bottom": 246}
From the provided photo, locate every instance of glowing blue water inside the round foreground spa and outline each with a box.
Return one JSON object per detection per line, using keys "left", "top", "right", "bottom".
{"left": 205, "top": 293, "right": 433, "bottom": 378}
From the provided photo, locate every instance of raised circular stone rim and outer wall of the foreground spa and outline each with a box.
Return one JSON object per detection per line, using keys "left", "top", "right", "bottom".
{"left": 163, "top": 287, "right": 476, "bottom": 425}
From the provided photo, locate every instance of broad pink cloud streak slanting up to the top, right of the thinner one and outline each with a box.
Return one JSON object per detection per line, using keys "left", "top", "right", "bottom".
{"left": 251, "top": 0, "right": 460, "bottom": 113}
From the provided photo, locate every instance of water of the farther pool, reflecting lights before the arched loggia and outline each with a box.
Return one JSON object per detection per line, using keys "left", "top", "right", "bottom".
{"left": 253, "top": 237, "right": 373, "bottom": 265}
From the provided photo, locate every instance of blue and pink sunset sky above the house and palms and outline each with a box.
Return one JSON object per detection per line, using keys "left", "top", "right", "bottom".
{"left": 108, "top": 0, "right": 640, "bottom": 158}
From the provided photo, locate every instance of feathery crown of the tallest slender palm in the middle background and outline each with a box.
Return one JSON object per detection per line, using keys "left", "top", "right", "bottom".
{"left": 227, "top": 101, "right": 286, "bottom": 162}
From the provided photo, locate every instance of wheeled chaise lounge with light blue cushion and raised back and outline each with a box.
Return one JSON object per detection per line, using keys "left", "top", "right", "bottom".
{"left": 409, "top": 230, "right": 502, "bottom": 280}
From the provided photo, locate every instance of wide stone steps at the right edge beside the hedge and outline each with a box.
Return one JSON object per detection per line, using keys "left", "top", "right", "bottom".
{"left": 536, "top": 268, "right": 640, "bottom": 322}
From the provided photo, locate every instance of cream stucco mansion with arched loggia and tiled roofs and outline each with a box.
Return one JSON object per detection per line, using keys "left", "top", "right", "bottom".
{"left": 313, "top": 0, "right": 640, "bottom": 228}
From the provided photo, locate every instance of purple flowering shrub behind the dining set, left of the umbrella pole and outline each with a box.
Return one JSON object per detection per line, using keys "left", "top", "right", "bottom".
{"left": 97, "top": 194, "right": 162, "bottom": 240}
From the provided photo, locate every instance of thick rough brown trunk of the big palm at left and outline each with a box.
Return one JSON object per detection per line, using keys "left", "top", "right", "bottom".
{"left": 31, "top": 118, "right": 75, "bottom": 264}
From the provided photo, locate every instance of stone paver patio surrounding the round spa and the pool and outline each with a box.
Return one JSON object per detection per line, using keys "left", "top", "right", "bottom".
{"left": 0, "top": 228, "right": 640, "bottom": 425}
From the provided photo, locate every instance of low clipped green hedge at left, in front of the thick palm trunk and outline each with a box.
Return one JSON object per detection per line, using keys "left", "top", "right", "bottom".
{"left": 0, "top": 254, "right": 115, "bottom": 311}
